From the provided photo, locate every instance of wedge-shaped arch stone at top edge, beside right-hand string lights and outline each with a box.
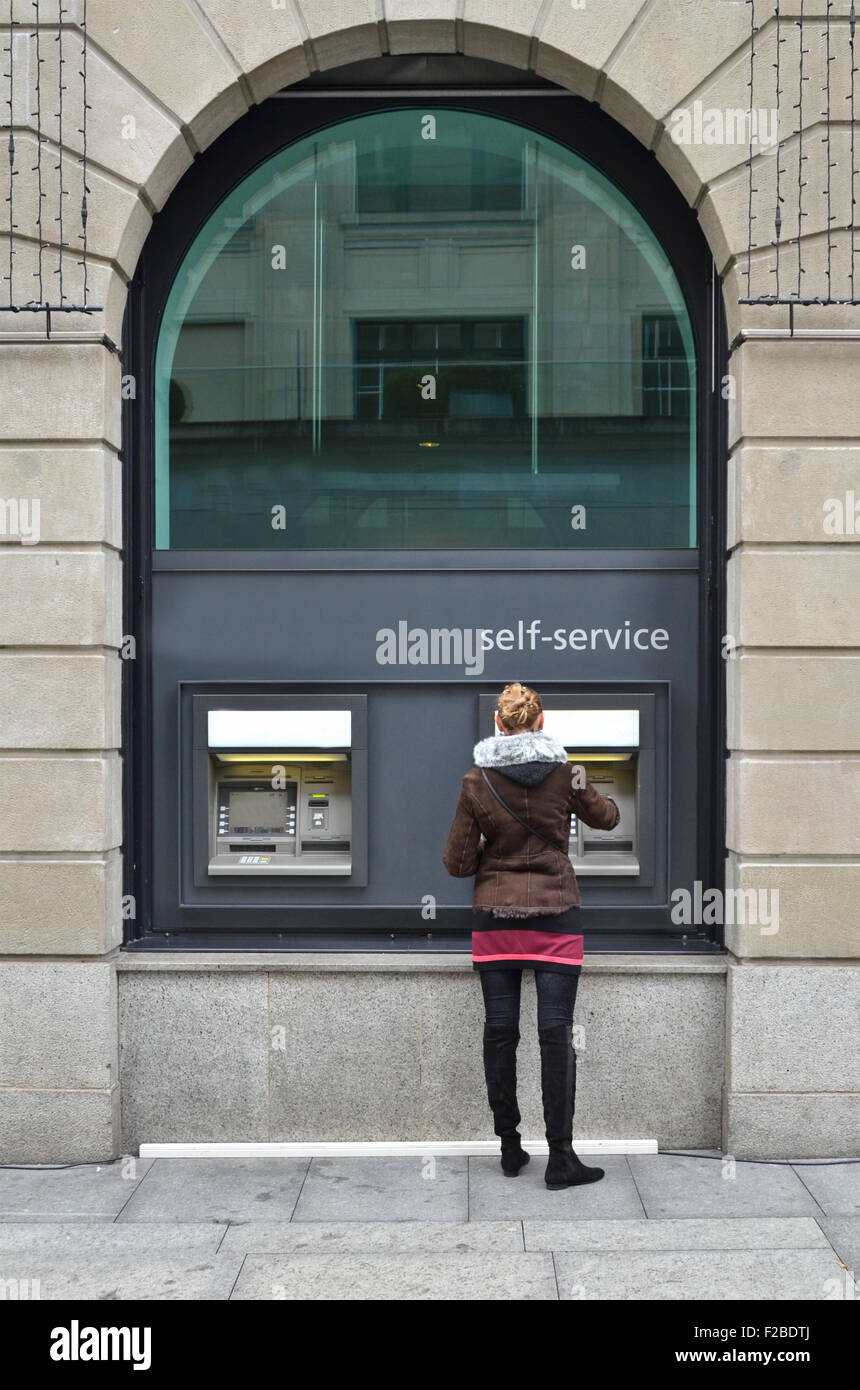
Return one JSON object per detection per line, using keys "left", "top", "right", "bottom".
{"left": 602, "top": 0, "right": 749, "bottom": 146}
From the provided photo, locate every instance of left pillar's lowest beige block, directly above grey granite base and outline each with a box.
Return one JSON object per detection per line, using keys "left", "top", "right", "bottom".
{"left": 0, "top": 851, "right": 122, "bottom": 955}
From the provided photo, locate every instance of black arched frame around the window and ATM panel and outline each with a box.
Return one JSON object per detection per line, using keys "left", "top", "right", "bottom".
{"left": 121, "top": 75, "right": 728, "bottom": 954}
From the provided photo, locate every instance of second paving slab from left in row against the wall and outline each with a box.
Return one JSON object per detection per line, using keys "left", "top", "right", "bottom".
{"left": 119, "top": 1158, "right": 310, "bottom": 1222}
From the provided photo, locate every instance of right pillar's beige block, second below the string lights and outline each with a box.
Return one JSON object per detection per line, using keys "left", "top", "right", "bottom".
{"left": 727, "top": 445, "right": 860, "bottom": 546}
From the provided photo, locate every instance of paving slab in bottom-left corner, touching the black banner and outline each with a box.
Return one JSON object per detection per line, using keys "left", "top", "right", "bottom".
{"left": 1, "top": 1251, "right": 242, "bottom": 1321}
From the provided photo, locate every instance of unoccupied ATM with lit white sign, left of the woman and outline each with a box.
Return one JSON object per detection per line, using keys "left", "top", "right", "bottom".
{"left": 207, "top": 708, "right": 353, "bottom": 877}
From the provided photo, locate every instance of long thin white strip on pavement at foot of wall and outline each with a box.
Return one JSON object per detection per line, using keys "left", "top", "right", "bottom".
{"left": 140, "top": 1138, "right": 657, "bottom": 1158}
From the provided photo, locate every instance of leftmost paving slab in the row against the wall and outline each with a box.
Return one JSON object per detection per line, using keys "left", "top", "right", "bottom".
{"left": 0, "top": 1158, "right": 153, "bottom": 1223}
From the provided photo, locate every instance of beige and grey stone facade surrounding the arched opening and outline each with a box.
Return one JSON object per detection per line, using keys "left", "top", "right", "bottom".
{"left": 0, "top": 0, "right": 860, "bottom": 1162}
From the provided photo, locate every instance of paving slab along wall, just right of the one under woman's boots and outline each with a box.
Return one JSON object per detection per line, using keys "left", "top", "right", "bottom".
{"left": 628, "top": 1154, "right": 821, "bottom": 1218}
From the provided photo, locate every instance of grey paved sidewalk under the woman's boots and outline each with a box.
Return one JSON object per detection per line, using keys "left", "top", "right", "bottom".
{"left": 0, "top": 1154, "right": 860, "bottom": 1300}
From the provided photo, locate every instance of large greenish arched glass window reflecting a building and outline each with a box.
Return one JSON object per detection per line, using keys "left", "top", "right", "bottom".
{"left": 156, "top": 106, "right": 697, "bottom": 550}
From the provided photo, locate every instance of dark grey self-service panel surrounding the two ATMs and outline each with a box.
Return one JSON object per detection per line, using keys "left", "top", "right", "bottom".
{"left": 153, "top": 571, "right": 699, "bottom": 930}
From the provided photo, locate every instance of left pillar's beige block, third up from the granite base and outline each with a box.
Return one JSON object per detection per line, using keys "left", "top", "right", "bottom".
{"left": 0, "top": 652, "right": 122, "bottom": 749}
